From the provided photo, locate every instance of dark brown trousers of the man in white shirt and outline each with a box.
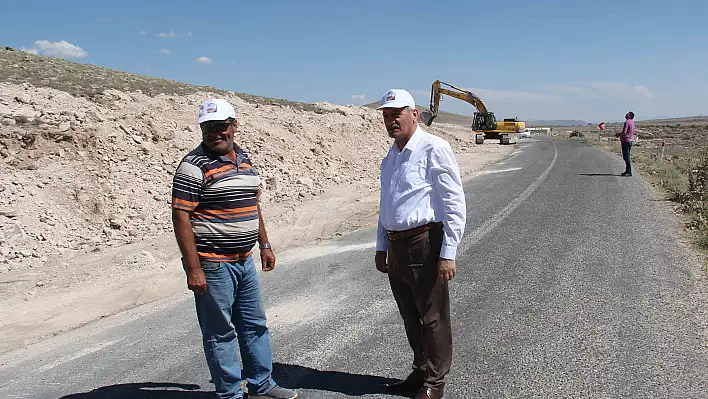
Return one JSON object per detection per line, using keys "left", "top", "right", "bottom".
{"left": 387, "top": 223, "right": 452, "bottom": 387}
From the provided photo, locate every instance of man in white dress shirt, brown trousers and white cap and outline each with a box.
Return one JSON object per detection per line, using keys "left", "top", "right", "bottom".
{"left": 375, "top": 89, "right": 467, "bottom": 399}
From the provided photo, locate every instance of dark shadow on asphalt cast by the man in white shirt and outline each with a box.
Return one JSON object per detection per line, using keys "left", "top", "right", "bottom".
{"left": 273, "top": 363, "right": 399, "bottom": 396}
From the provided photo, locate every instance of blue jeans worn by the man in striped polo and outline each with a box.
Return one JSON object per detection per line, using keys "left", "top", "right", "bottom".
{"left": 195, "top": 255, "right": 275, "bottom": 398}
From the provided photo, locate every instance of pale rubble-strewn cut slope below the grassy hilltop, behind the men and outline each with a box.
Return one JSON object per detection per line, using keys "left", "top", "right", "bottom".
{"left": 0, "top": 83, "right": 470, "bottom": 271}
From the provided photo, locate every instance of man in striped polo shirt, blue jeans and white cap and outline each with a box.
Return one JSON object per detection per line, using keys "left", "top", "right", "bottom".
{"left": 172, "top": 99, "right": 297, "bottom": 399}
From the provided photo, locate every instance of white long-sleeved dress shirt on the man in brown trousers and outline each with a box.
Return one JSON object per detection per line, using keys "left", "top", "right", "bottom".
{"left": 376, "top": 127, "right": 467, "bottom": 260}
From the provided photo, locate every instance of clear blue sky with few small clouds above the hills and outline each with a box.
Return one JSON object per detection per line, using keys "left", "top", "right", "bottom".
{"left": 0, "top": 0, "right": 708, "bottom": 122}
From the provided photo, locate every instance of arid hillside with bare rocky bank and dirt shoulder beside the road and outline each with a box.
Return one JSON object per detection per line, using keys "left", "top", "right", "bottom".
{"left": 0, "top": 49, "right": 514, "bottom": 352}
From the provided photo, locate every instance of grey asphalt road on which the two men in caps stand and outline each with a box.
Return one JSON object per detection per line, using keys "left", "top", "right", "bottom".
{"left": 0, "top": 139, "right": 708, "bottom": 399}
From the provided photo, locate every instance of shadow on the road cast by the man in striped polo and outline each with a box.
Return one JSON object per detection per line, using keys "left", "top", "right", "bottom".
{"left": 61, "top": 382, "right": 214, "bottom": 399}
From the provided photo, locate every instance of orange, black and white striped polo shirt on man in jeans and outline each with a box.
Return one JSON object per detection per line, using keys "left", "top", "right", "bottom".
{"left": 172, "top": 144, "right": 261, "bottom": 262}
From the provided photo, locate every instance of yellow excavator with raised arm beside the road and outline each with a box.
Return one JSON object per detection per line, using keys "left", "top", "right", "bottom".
{"left": 421, "top": 80, "right": 526, "bottom": 144}
